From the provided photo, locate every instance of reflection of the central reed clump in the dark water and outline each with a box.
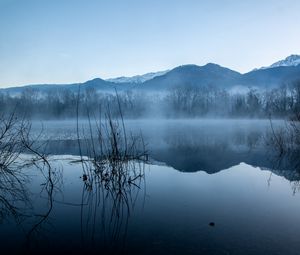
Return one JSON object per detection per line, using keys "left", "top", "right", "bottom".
{"left": 81, "top": 161, "right": 145, "bottom": 254}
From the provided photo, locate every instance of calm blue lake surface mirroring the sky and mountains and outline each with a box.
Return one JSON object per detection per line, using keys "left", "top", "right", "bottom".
{"left": 0, "top": 120, "right": 300, "bottom": 254}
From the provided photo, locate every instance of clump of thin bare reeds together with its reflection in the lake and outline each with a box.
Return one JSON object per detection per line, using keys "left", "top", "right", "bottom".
{"left": 77, "top": 88, "right": 148, "bottom": 252}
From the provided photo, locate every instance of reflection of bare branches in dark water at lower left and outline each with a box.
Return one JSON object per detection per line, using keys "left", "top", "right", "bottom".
{"left": 0, "top": 154, "right": 59, "bottom": 254}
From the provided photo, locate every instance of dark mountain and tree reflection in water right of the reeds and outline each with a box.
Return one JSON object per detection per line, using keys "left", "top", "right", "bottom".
{"left": 39, "top": 120, "right": 299, "bottom": 180}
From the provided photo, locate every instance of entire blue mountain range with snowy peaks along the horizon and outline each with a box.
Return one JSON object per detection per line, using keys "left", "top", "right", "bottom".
{"left": 0, "top": 55, "right": 300, "bottom": 94}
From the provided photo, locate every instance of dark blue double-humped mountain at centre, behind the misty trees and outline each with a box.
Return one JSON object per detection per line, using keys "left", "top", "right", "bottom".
{"left": 142, "top": 63, "right": 241, "bottom": 90}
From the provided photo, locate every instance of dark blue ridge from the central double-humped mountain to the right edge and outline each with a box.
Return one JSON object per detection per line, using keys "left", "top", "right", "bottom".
{"left": 141, "top": 60, "right": 300, "bottom": 90}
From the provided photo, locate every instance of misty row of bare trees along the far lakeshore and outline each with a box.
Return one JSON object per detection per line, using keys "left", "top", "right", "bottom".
{"left": 0, "top": 81, "right": 300, "bottom": 119}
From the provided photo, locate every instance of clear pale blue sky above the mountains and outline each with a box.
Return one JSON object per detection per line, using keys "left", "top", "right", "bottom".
{"left": 0, "top": 0, "right": 300, "bottom": 87}
